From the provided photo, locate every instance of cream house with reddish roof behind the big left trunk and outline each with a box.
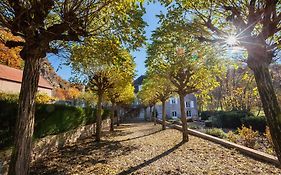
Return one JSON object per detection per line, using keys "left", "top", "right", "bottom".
{"left": 0, "top": 64, "right": 53, "bottom": 96}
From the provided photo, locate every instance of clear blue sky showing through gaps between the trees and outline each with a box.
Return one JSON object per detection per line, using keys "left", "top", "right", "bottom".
{"left": 48, "top": 2, "right": 166, "bottom": 80}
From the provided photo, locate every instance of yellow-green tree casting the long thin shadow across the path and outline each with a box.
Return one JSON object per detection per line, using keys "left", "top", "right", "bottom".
{"left": 147, "top": 19, "right": 220, "bottom": 142}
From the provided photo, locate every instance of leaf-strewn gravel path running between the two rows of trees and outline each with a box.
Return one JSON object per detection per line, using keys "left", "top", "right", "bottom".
{"left": 31, "top": 118, "right": 281, "bottom": 175}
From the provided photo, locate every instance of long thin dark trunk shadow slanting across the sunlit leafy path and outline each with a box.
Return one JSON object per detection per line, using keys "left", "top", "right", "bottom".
{"left": 118, "top": 142, "right": 184, "bottom": 175}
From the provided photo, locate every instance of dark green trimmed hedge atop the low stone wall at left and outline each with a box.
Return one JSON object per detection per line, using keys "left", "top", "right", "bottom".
{"left": 0, "top": 101, "right": 109, "bottom": 149}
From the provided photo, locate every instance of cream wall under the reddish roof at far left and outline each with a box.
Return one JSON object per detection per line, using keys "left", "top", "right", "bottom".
{"left": 0, "top": 80, "right": 52, "bottom": 96}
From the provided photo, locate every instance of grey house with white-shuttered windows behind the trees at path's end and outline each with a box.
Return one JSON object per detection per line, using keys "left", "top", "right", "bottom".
{"left": 134, "top": 75, "right": 198, "bottom": 120}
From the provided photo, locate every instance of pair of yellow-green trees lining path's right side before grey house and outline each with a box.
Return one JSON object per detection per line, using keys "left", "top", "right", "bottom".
{"left": 139, "top": 18, "right": 219, "bottom": 142}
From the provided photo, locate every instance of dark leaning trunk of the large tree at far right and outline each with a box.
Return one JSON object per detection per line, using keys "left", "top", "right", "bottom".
{"left": 251, "top": 65, "right": 281, "bottom": 161}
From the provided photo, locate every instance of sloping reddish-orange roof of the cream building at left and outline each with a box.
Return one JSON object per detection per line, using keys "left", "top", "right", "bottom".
{"left": 0, "top": 64, "right": 53, "bottom": 89}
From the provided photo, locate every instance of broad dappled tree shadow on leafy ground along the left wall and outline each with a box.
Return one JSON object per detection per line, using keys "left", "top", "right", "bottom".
{"left": 30, "top": 138, "right": 137, "bottom": 175}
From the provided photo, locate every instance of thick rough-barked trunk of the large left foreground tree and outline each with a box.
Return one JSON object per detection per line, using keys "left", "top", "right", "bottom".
{"left": 8, "top": 58, "right": 41, "bottom": 175}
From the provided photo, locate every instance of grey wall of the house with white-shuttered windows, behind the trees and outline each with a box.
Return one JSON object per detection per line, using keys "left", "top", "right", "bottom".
{"left": 156, "top": 94, "right": 198, "bottom": 119}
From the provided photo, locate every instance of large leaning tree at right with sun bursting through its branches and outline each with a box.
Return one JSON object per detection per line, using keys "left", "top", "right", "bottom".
{"left": 161, "top": 0, "right": 281, "bottom": 160}
